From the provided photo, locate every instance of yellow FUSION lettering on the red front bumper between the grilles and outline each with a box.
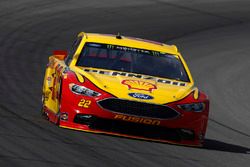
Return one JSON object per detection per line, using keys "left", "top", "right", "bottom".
{"left": 114, "top": 114, "right": 161, "bottom": 125}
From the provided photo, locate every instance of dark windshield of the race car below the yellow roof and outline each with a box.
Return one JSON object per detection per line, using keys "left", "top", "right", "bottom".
{"left": 76, "top": 43, "right": 189, "bottom": 82}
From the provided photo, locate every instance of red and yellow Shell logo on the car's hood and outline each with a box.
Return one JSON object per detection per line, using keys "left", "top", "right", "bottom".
{"left": 122, "top": 80, "right": 157, "bottom": 92}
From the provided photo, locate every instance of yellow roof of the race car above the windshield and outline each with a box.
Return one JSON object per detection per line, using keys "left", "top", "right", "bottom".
{"left": 78, "top": 32, "right": 178, "bottom": 54}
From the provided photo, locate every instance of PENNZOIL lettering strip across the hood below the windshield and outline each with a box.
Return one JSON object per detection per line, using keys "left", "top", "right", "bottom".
{"left": 83, "top": 68, "right": 186, "bottom": 86}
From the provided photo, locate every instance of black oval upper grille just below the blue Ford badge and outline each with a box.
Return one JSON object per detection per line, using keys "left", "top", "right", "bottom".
{"left": 98, "top": 98, "right": 179, "bottom": 119}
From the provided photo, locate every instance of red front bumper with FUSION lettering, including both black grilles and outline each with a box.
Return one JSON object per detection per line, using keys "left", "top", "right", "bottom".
{"left": 56, "top": 83, "right": 208, "bottom": 146}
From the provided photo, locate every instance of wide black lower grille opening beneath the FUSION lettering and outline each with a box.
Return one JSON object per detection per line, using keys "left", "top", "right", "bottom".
{"left": 74, "top": 114, "right": 195, "bottom": 141}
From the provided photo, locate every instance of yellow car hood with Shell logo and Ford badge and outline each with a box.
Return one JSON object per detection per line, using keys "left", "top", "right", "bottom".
{"left": 77, "top": 68, "right": 193, "bottom": 104}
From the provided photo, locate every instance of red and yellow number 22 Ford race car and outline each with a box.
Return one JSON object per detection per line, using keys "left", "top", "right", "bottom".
{"left": 42, "top": 32, "right": 209, "bottom": 146}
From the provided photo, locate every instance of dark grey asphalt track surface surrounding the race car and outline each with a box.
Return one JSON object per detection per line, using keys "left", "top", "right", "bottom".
{"left": 0, "top": 0, "right": 250, "bottom": 167}
